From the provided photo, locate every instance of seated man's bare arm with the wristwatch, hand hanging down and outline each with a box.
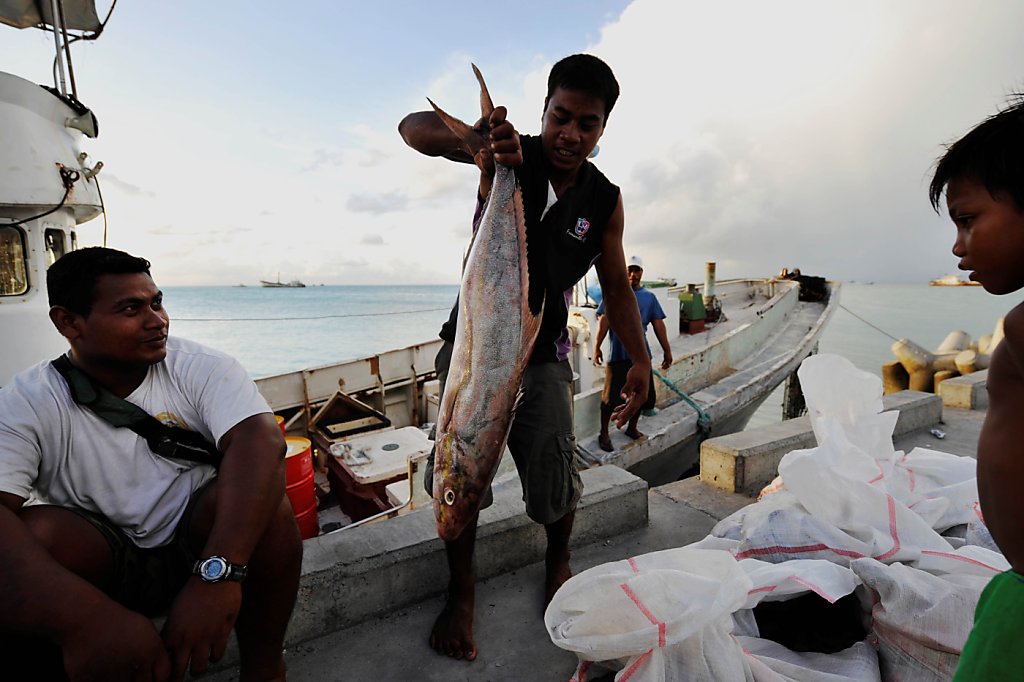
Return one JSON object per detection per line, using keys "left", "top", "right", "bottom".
{"left": 164, "top": 413, "right": 285, "bottom": 679}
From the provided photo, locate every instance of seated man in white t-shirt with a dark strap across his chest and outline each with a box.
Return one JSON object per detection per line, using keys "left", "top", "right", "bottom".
{"left": 0, "top": 248, "right": 302, "bottom": 681}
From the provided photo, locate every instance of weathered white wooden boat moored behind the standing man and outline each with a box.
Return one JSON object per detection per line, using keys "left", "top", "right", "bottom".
{"left": 249, "top": 279, "right": 839, "bottom": 528}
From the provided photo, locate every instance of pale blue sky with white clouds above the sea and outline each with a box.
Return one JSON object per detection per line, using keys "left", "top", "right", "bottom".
{"left": 6, "top": 0, "right": 1024, "bottom": 286}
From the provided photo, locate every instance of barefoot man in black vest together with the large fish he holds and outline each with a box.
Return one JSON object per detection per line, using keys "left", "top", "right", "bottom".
{"left": 399, "top": 54, "right": 650, "bottom": 660}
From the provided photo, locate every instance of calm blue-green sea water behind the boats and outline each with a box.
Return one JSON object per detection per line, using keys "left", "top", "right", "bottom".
{"left": 165, "top": 283, "right": 1022, "bottom": 424}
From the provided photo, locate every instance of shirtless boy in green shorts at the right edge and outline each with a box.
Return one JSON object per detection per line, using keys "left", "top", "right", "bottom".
{"left": 929, "top": 98, "right": 1024, "bottom": 682}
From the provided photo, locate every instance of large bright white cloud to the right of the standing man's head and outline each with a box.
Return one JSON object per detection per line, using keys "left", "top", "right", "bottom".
{"left": 590, "top": 0, "right": 1024, "bottom": 282}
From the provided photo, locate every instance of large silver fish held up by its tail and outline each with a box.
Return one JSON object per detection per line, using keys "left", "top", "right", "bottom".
{"left": 430, "top": 66, "right": 542, "bottom": 540}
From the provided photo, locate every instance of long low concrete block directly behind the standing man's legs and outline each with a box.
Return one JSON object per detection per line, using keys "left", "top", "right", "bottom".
{"left": 286, "top": 466, "right": 647, "bottom": 643}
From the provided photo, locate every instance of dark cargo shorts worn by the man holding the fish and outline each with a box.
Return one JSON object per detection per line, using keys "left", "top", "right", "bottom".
{"left": 423, "top": 341, "right": 583, "bottom": 524}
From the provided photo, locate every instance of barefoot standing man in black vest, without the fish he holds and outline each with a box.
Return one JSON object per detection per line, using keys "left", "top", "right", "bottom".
{"left": 398, "top": 54, "right": 650, "bottom": 660}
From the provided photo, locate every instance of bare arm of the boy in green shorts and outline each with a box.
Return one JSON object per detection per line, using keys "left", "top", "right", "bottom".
{"left": 978, "top": 304, "right": 1024, "bottom": 574}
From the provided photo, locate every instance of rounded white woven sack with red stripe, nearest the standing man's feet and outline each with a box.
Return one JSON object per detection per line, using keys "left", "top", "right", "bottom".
{"left": 544, "top": 548, "right": 753, "bottom": 682}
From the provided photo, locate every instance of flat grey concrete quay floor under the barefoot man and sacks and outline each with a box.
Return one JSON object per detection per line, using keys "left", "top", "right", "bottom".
{"left": 204, "top": 378, "right": 984, "bottom": 682}
